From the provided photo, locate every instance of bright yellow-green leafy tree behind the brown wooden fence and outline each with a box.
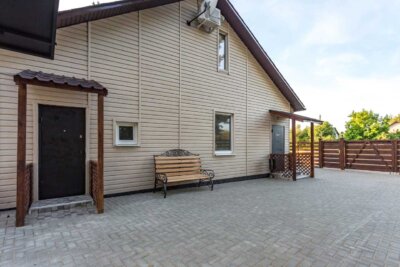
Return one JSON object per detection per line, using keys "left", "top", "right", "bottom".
{"left": 344, "top": 110, "right": 390, "bottom": 140}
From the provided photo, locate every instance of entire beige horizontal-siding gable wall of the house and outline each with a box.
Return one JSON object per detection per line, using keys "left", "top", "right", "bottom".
{"left": 0, "top": 0, "right": 290, "bottom": 209}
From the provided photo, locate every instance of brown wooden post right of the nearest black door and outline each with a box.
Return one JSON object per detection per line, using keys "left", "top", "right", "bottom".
{"left": 96, "top": 94, "right": 104, "bottom": 213}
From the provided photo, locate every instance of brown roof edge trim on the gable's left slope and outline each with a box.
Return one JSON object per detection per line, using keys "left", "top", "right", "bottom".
{"left": 57, "top": 0, "right": 181, "bottom": 28}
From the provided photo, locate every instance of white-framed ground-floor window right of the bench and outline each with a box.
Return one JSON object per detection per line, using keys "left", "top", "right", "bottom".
{"left": 214, "top": 112, "right": 233, "bottom": 155}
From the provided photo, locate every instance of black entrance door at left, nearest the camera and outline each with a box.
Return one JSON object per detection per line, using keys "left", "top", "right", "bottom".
{"left": 39, "top": 105, "right": 85, "bottom": 199}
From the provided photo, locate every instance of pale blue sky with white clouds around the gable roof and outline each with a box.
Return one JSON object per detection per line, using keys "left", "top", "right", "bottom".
{"left": 60, "top": 0, "right": 400, "bottom": 131}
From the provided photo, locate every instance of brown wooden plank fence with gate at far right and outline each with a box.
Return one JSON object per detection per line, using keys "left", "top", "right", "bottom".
{"left": 316, "top": 139, "right": 400, "bottom": 173}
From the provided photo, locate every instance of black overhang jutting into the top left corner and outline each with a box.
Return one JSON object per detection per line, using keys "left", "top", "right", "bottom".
{"left": 0, "top": 0, "right": 59, "bottom": 59}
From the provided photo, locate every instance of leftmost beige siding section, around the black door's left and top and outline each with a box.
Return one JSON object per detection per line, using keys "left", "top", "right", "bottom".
{"left": 0, "top": 24, "right": 87, "bottom": 209}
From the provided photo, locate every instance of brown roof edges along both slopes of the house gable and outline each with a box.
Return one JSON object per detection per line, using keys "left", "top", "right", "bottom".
{"left": 57, "top": 0, "right": 305, "bottom": 111}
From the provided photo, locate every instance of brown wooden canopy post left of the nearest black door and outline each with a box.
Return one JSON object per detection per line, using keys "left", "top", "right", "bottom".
{"left": 15, "top": 83, "right": 26, "bottom": 227}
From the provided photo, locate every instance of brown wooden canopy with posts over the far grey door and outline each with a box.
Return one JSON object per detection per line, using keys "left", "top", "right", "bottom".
{"left": 269, "top": 110, "right": 323, "bottom": 181}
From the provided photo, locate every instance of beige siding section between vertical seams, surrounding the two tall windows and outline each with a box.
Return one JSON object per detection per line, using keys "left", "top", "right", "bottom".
{"left": 181, "top": 1, "right": 246, "bottom": 179}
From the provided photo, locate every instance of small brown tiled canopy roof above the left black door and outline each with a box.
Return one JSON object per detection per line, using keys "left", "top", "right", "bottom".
{"left": 14, "top": 70, "right": 108, "bottom": 96}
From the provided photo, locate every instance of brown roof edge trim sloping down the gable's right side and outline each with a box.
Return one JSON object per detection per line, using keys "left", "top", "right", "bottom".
{"left": 218, "top": 0, "right": 306, "bottom": 111}
